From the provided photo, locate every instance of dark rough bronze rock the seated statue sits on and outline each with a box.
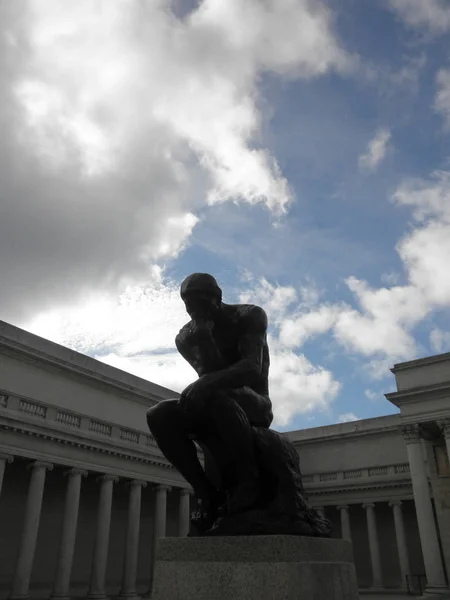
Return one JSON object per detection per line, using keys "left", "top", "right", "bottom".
{"left": 191, "top": 427, "right": 331, "bottom": 537}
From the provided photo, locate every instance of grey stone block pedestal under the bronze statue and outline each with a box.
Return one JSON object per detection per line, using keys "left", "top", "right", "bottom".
{"left": 152, "top": 535, "right": 359, "bottom": 600}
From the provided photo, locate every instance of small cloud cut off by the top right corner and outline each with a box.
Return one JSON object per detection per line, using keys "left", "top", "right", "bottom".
{"left": 389, "top": 0, "right": 450, "bottom": 34}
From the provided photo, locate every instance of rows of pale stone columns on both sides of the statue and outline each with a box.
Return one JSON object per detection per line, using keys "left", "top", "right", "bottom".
{"left": 0, "top": 421, "right": 450, "bottom": 600}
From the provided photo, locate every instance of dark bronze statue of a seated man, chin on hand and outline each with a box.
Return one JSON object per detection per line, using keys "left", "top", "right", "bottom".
{"left": 147, "top": 273, "right": 331, "bottom": 537}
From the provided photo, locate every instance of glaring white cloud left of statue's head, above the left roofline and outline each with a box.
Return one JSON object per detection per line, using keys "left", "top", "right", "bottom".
{"left": 25, "top": 270, "right": 187, "bottom": 357}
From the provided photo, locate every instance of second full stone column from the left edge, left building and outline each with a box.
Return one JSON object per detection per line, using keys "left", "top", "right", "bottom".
{"left": 50, "top": 469, "right": 88, "bottom": 600}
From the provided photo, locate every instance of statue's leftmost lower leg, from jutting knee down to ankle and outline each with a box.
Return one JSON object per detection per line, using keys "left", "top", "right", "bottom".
{"left": 147, "top": 400, "right": 214, "bottom": 498}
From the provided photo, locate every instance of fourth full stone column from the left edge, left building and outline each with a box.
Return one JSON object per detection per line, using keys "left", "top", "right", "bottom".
{"left": 119, "top": 479, "right": 147, "bottom": 600}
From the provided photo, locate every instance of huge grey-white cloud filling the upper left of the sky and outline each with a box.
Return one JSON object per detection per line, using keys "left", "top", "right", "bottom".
{"left": 0, "top": 0, "right": 352, "bottom": 322}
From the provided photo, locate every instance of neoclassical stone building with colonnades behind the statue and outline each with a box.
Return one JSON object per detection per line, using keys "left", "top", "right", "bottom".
{"left": 0, "top": 322, "right": 450, "bottom": 600}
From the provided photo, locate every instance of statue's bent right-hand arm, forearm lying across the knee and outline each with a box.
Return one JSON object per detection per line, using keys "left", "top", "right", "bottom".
{"left": 186, "top": 306, "right": 267, "bottom": 394}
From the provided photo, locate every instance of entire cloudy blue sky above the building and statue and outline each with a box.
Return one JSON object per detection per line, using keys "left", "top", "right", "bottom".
{"left": 0, "top": 0, "right": 450, "bottom": 431}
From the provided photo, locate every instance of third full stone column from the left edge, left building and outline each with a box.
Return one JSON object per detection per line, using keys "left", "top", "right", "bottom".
{"left": 87, "top": 475, "right": 119, "bottom": 599}
